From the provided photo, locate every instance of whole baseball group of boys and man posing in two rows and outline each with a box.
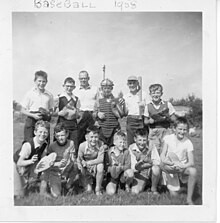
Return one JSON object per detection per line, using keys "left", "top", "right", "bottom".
{"left": 14, "top": 71, "right": 196, "bottom": 204}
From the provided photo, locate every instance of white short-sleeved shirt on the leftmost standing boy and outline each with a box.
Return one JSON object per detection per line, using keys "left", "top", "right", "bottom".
{"left": 21, "top": 87, "right": 54, "bottom": 111}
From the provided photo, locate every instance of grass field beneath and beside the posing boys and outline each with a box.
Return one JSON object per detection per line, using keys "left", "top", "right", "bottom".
{"left": 13, "top": 118, "right": 202, "bottom": 206}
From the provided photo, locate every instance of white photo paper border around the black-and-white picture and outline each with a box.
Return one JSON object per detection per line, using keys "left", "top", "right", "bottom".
{"left": 0, "top": 0, "right": 217, "bottom": 221}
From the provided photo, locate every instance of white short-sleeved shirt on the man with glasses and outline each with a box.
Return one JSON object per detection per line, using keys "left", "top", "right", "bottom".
{"left": 74, "top": 85, "right": 98, "bottom": 111}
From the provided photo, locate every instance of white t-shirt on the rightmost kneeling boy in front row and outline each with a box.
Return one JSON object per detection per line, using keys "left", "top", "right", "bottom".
{"left": 164, "top": 134, "right": 194, "bottom": 163}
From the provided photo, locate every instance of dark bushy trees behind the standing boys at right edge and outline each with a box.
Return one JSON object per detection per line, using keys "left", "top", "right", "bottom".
{"left": 169, "top": 94, "right": 203, "bottom": 128}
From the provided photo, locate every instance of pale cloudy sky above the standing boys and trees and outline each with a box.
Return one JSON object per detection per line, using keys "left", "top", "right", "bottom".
{"left": 12, "top": 12, "right": 202, "bottom": 102}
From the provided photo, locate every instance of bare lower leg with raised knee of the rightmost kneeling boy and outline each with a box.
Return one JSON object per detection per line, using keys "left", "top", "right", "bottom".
{"left": 185, "top": 167, "right": 197, "bottom": 204}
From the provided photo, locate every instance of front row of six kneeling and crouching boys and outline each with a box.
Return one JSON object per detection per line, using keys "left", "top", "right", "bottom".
{"left": 14, "top": 118, "right": 196, "bottom": 204}
